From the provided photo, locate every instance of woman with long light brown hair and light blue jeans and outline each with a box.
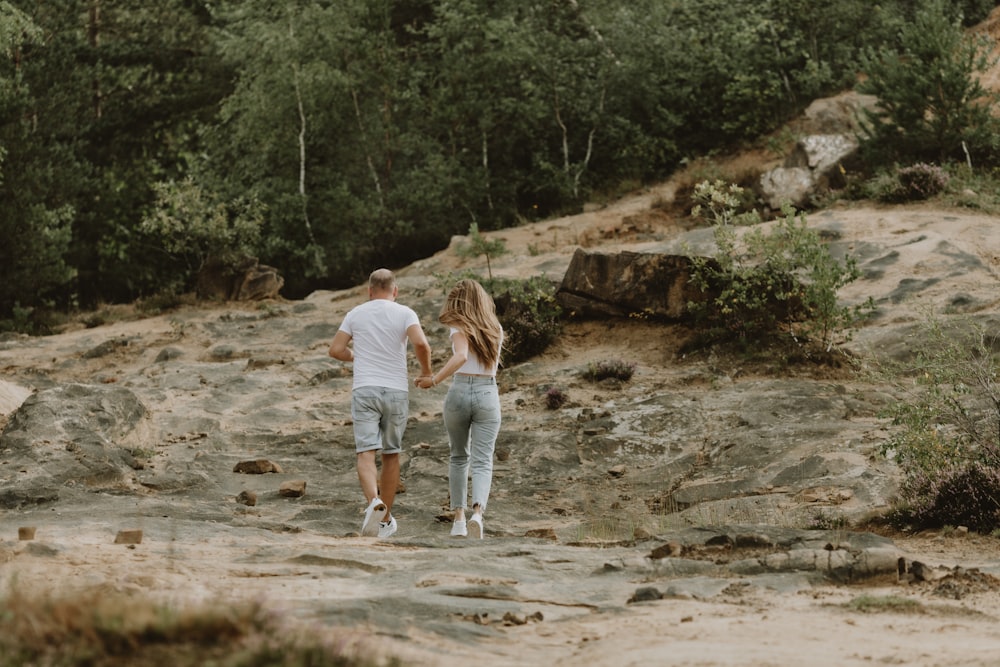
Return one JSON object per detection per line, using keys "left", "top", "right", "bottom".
{"left": 416, "top": 280, "right": 503, "bottom": 539}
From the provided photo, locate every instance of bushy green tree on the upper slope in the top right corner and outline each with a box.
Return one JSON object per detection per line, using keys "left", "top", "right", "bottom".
{"left": 858, "top": 0, "right": 1000, "bottom": 165}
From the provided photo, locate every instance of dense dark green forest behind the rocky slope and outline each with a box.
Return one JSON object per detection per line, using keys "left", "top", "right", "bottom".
{"left": 0, "top": 0, "right": 1000, "bottom": 331}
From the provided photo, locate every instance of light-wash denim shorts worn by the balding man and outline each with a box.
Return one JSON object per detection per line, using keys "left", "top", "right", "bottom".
{"left": 351, "top": 387, "right": 410, "bottom": 454}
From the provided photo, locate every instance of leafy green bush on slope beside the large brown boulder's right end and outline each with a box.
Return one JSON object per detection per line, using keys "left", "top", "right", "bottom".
{"left": 688, "top": 181, "right": 872, "bottom": 351}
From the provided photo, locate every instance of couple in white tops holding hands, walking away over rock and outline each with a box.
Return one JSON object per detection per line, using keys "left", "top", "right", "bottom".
{"left": 330, "top": 269, "right": 503, "bottom": 538}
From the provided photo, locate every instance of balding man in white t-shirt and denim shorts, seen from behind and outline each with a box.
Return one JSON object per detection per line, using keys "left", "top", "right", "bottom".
{"left": 330, "top": 269, "right": 433, "bottom": 537}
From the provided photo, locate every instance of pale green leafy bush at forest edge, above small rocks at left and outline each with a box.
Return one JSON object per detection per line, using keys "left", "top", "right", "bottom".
{"left": 141, "top": 179, "right": 264, "bottom": 290}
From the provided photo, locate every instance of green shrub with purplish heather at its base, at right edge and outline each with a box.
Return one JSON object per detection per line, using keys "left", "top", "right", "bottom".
{"left": 866, "top": 318, "right": 1000, "bottom": 532}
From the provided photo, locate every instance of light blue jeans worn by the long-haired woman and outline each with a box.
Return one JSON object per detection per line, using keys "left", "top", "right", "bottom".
{"left": 444, "top": 375, "right": 500, "bottom": 511}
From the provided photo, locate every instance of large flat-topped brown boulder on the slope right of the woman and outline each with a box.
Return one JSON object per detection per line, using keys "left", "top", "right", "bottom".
{"left": 556, "top": 248, "right": 702, "bottom": 320}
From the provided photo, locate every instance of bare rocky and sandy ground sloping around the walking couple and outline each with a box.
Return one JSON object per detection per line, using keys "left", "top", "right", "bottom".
{"left": 0, "top": 186, "right": 1000, "bottom": 665}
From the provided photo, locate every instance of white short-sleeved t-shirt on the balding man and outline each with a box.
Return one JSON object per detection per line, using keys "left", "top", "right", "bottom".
{"left": 340, "top": 299, "right": 420, "bottom": 391}
